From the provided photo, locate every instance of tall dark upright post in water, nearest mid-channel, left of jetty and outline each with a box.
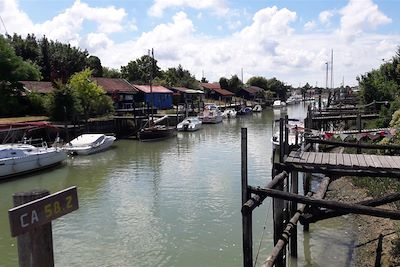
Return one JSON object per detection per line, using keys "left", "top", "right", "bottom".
{"left": 241, "top": 128, "right": 253, "bottom": 267}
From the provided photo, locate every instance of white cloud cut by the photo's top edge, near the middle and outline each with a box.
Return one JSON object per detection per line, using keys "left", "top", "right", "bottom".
{"left": 148, "top": 0, "right": 229, "bottom": 17}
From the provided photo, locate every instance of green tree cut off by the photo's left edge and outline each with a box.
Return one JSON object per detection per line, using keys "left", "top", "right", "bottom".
{"left": 0, "top": 35, "right": 41, "bottom": 116}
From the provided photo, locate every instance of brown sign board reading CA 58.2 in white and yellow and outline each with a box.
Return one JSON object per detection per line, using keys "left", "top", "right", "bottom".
{"left": 8, "top": 186, "right": 79, "bottom": 237}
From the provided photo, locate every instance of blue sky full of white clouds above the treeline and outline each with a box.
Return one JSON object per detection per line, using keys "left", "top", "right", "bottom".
{"left": 0, "top": 0, "right": 400, "bottom": 87}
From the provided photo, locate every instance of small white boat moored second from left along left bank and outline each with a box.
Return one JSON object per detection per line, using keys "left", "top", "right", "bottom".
{"left": 64, "top": 134, "right": 116, "bottom": 155}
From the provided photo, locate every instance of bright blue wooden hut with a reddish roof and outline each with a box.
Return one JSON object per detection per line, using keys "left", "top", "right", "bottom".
{"left": 133, "top": 84, "right": 173, "bottom": 109}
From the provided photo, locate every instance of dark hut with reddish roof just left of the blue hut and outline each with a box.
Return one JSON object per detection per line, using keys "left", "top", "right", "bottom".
{"left": 91, "top": 77, "right": 138, "bottom": 110}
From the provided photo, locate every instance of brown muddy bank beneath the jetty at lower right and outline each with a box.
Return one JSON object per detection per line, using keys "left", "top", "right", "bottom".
{"left": 326, "top": 177, "right": 400, "bottom": 267}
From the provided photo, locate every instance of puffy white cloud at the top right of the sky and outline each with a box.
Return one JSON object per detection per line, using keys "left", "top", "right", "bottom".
{"left": 339, "top": 0, "right": 392, "bottom": 41}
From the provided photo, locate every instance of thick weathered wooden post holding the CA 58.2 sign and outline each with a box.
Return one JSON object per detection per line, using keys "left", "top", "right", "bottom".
{"left": 13, "top": 190, "right": 54, "bottom": 267}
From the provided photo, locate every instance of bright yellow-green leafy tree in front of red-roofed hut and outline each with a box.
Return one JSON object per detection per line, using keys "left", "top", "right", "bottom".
{"left": 68, "top": 69, "right": 113, "bottom": 122}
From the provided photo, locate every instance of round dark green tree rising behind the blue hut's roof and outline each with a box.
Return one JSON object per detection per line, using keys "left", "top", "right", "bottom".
{"left": 121, "top": 55, "right": 162, "bottom": 84}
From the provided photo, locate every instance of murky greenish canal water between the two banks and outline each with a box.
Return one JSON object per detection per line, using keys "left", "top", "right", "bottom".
{"left": 0, "top": 104, "right": 353, "bottom": 267}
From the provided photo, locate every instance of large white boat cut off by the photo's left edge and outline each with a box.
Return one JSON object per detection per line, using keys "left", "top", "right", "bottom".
{"left": 0, "top": 144, "right": 67, "bottom": 179}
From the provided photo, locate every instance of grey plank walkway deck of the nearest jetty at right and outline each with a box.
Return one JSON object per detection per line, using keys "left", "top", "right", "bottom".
{"left": 285, "top": 151, "right": 400, "bottom": 177}
